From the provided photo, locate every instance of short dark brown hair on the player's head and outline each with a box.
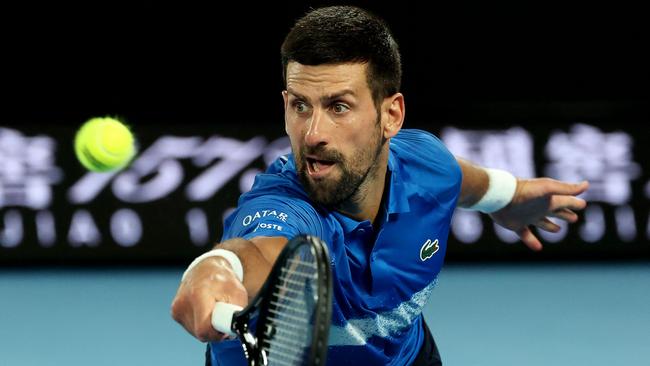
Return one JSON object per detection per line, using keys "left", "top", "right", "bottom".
{"left": 281, "top": 6, "right": 402, "bottom": 105}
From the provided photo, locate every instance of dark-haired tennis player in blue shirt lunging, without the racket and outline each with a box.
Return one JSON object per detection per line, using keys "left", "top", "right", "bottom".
{"left": 172, "top": 6, "right": 588, "bottom": 366}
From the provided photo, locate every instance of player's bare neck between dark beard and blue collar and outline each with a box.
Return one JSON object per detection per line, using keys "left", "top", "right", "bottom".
{"left": 336, "top": 144, "right": 388, "bottom": 223}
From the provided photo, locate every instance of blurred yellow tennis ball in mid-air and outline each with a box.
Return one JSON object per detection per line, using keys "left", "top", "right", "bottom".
{"left": 74, "top": 117, "right": 136, "bottom": 172}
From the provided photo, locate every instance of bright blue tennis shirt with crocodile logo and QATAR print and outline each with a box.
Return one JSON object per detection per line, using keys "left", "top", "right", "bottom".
{"left": 209, "top": 130, "right": 462, "bottom": 366}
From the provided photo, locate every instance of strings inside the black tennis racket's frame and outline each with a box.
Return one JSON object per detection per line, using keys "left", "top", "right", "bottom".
{"left": 261, "top": 246, "right": 318, "bottom": 365}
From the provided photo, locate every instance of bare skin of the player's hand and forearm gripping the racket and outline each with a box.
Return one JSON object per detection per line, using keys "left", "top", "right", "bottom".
{"left": 171, "top": 237, "right": 288, "bottom": 342}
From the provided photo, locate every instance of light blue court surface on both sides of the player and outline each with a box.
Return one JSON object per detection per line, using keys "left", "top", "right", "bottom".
{"left": 0, "top": 263, "right": 650, "bottom": 366}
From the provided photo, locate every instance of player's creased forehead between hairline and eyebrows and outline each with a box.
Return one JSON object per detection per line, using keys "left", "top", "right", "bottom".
{"left": 287, "top": 62, "right": 370, "bottom": 95}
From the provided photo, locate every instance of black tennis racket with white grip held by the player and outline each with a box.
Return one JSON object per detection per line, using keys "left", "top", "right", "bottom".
{"left": 212, "top": 235, "right": 332, "bottom": 366}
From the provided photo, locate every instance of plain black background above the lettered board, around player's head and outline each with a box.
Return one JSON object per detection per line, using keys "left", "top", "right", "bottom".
{"left": 2, "top": 1, "right": 648, "bottom": 118}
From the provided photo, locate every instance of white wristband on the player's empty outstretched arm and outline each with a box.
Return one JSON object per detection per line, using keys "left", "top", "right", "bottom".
{"left": 467, "top": 169, "right": 517, "bottom": 213}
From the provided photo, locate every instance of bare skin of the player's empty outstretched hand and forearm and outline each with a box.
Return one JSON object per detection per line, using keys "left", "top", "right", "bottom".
{"left": 457, "top": 158, "right": 589, "bottom": 251}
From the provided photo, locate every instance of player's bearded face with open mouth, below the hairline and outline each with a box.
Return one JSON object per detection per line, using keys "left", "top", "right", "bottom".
{"left": 283, "top": 62, "right": 384, "bottom": 206}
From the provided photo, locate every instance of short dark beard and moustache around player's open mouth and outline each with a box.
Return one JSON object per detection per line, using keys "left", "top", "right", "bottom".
{"left": 295, "top": 121, "right": 386, "bottom": 207}
